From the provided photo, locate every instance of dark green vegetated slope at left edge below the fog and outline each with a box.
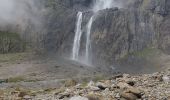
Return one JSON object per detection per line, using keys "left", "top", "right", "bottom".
{"left": 0, "top": 31, "right": 26, "bottom": 54}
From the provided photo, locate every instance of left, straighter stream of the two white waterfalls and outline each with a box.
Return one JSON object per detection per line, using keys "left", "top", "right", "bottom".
{"left": 72, "top": 12, "right": 83, "bottom": 60}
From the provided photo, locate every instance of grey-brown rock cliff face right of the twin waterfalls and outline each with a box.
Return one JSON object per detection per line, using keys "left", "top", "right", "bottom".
{"left": 92, "top": 0, "right": 170, "bottom": 65}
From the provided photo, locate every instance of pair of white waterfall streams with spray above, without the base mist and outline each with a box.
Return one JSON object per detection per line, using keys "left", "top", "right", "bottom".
{"left": 72, "top": 0, "right": 114, "bottom": 64}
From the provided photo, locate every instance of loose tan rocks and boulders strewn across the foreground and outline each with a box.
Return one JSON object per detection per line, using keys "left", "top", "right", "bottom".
{"left": 0, "top": 69, "right": 170, "bottom": 100}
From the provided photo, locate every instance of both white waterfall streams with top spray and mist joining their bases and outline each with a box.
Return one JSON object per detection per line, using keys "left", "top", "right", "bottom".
{"left": 71, "top": 0, "right": 121, "bottom": 65}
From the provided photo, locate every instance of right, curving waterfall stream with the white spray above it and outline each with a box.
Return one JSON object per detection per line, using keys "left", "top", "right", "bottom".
{"left": 85, "top": 0, "right": 113, "bottom": 64}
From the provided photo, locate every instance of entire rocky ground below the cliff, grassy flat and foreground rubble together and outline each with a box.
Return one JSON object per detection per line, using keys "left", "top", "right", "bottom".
{"left": 0, "top": 54, "right": 170, "bottom": 100}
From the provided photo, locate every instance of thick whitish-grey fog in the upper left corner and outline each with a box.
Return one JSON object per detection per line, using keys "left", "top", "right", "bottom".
{"left": 0, "top": 0, "right": 44, "bottom": 30}
